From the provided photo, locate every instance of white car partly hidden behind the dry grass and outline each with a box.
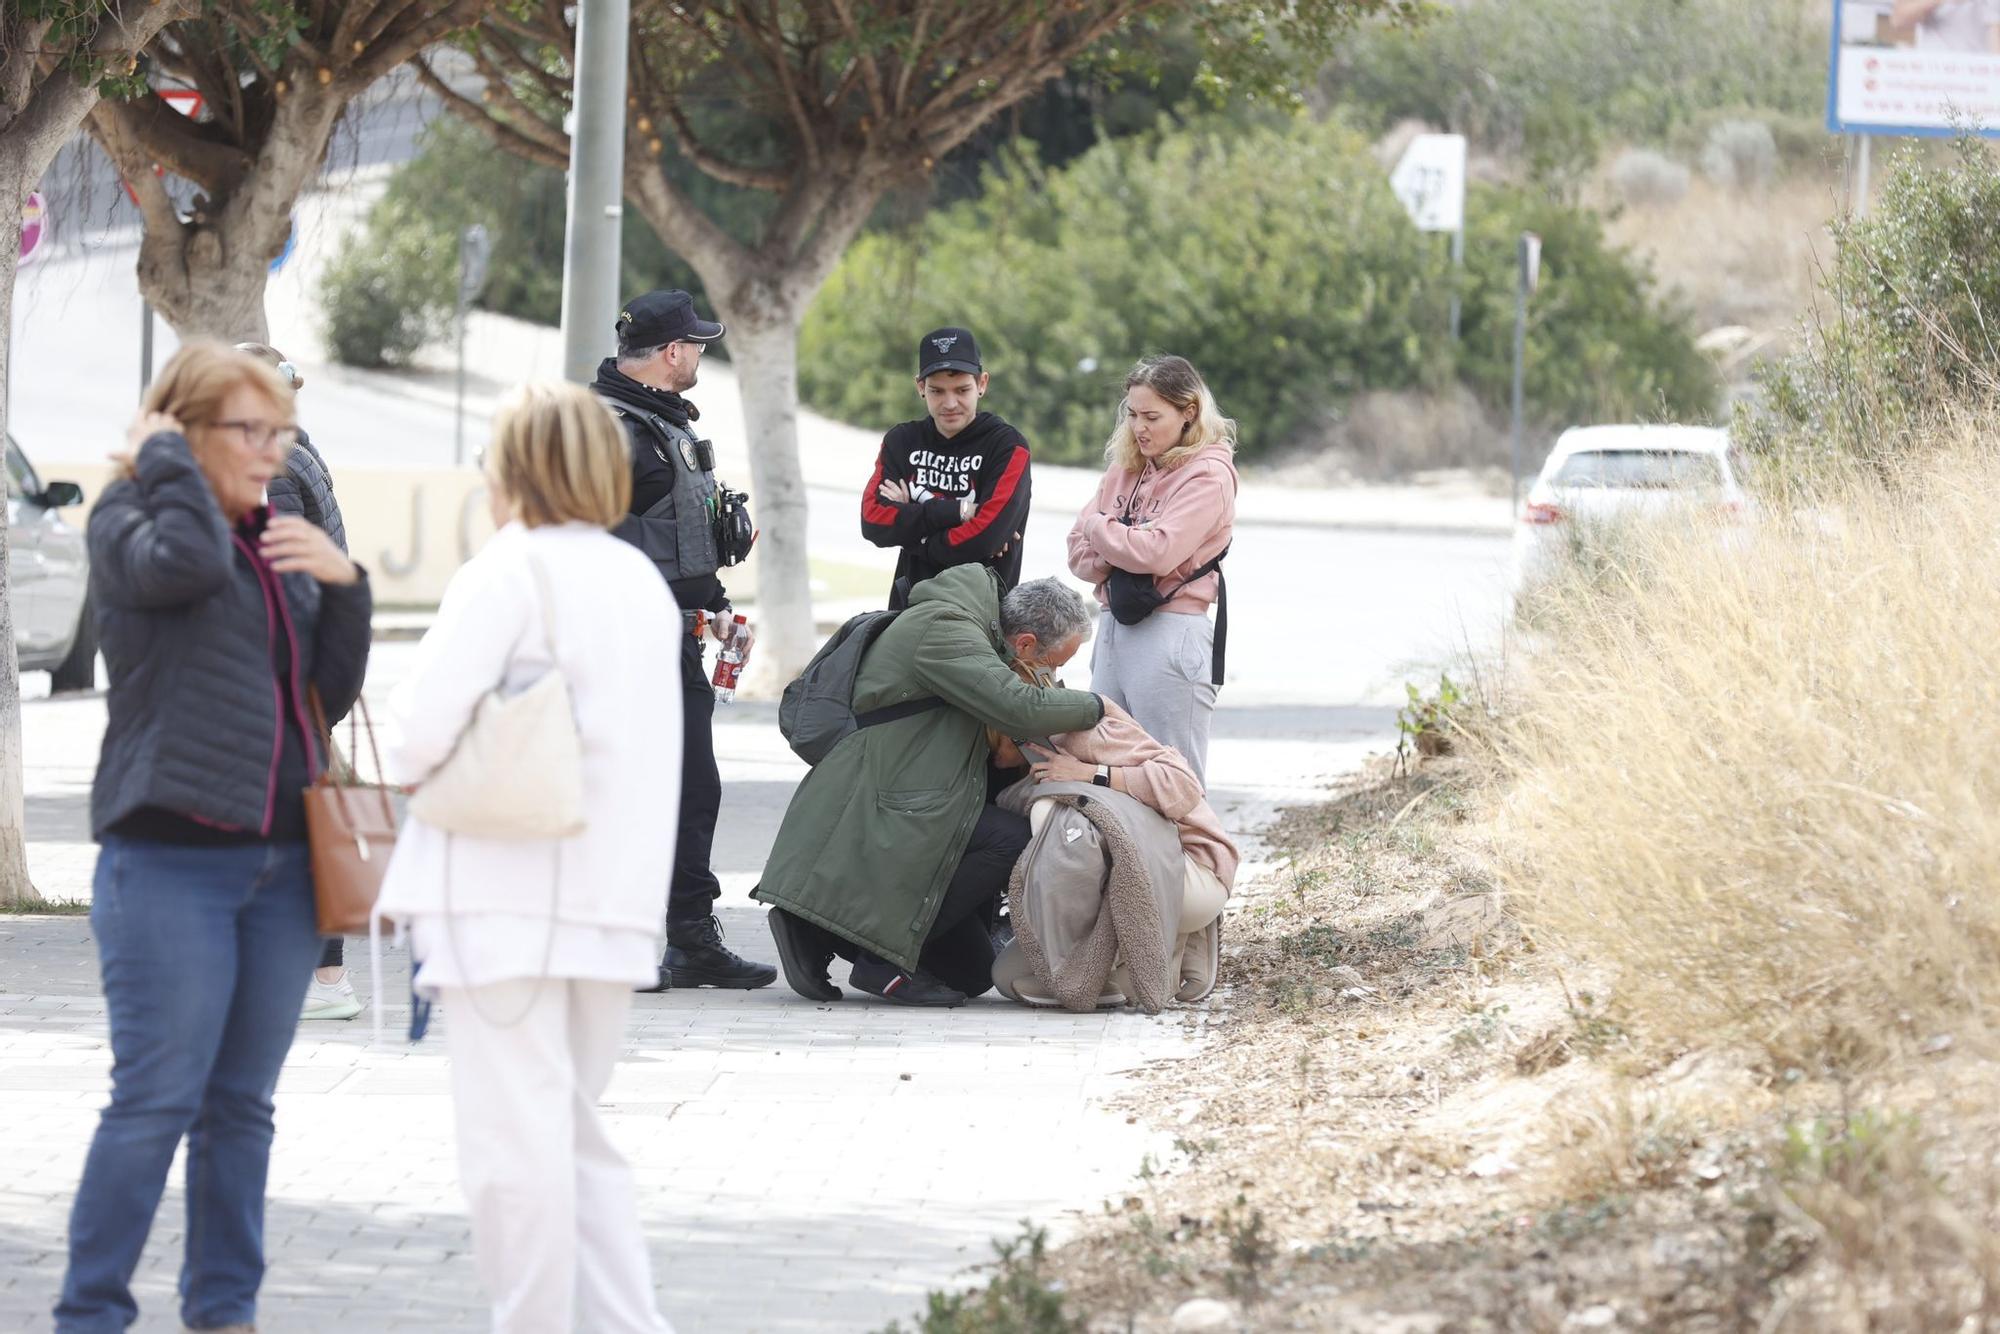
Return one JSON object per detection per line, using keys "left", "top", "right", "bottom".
{"left": 1514, "top": 426, "right": 1748, "bottom": 596}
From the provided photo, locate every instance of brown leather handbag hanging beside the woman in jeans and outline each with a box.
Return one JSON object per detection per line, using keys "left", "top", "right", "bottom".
{"left": 306, "top": 690, "right": 396, "bottom": 936}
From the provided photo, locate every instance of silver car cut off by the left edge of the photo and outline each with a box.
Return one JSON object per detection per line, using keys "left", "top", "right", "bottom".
{"left": 6, "top": 436, "right": 98, "bottom": 692}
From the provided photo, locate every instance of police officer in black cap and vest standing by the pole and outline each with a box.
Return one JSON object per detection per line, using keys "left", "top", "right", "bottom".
{"left": 592, "top": 292, "right": 778, "bottom": 990}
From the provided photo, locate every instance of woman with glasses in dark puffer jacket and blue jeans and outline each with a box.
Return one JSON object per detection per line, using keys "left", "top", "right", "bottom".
{"left": 56, "top": 344, "right": 370, "bottom": 1332}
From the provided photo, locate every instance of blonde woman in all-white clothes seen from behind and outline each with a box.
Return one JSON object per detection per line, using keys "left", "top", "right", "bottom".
{"left": 382, "top": 384, "right": 680, "bottom": 1334}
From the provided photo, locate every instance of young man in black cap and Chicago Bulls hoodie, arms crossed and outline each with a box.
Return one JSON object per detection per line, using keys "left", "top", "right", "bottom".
{"left": 862, "top": 328, "right": 1028, "bottom": 610}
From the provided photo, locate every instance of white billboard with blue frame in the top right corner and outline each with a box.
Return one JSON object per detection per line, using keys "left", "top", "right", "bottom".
{"left": 1826, "top": 0, "right": 2000, "bottom": 136}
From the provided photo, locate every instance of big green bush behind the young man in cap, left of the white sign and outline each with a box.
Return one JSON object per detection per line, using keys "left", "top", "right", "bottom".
{"left": 800, "top": 124, "right": 1446, "bottom": 460}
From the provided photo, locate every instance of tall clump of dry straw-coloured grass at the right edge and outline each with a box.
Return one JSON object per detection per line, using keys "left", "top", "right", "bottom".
{"left": 1500, "top": 440, "right": 2000, "bottom": 1072}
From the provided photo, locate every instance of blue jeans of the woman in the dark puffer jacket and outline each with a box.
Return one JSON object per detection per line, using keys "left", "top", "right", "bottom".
{"left": 56, "top": 838, "right": 320, "bottom": 1334}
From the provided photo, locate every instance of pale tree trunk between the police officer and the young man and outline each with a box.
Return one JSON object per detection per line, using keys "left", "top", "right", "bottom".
{"left": 722, "top": 304, "right": 814, "bottom": 694}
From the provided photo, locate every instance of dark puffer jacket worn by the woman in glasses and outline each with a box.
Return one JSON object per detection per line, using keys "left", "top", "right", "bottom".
{"left": 88, "top": 432, "right": 372, "bottom": 836}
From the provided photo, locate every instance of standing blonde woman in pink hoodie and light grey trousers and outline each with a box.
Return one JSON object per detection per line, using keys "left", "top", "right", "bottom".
{"left": 1070, "top": 356, "right": 1236, "bottom": 788}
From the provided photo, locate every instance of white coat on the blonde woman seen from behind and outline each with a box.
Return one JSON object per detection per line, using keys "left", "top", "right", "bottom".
{"left": 380, "top": 524, "right": 684, "bottom": 948}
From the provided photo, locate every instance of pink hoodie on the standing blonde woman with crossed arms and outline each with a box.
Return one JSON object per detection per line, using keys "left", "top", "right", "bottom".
{"left": 1070, "top": 442, "right": 1236, "bottom": 614}
